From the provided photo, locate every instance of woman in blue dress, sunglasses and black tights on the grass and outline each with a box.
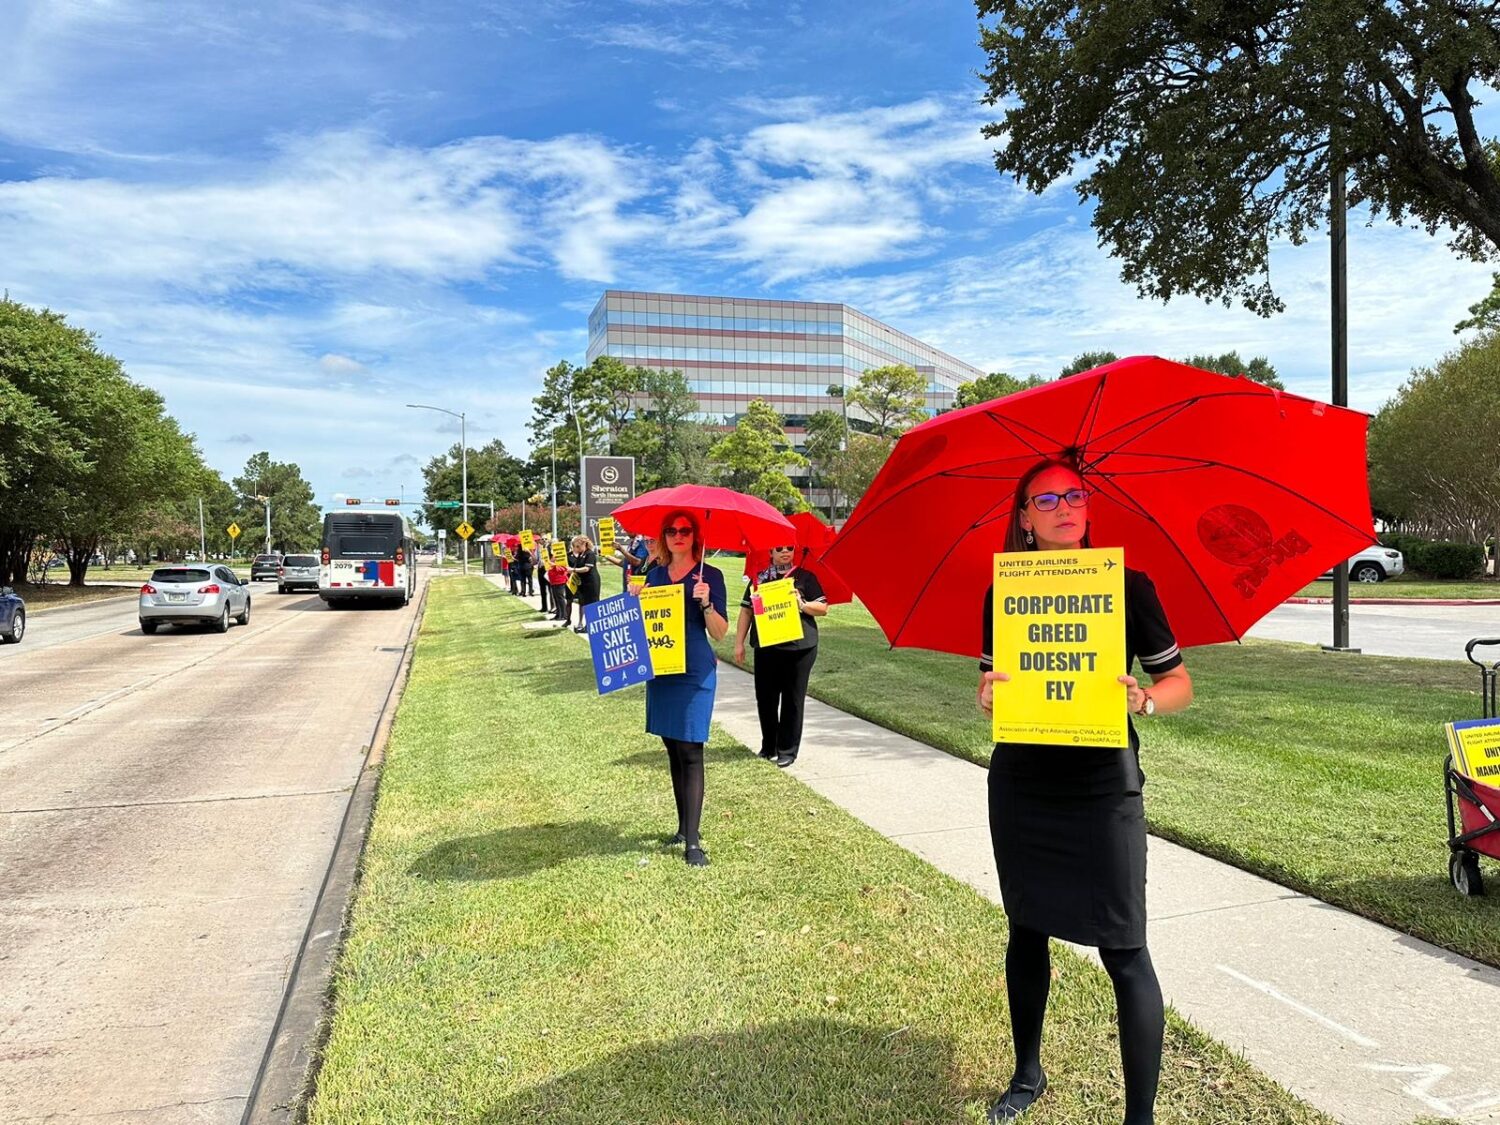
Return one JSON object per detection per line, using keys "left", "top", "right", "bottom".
{"left": 647, "top": 512, "right": 729, "bottom": 867}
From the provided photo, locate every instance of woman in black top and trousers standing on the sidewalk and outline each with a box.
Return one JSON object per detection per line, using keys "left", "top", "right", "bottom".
{"left": 735, "top": 546, "right": 828, "bottom": 770}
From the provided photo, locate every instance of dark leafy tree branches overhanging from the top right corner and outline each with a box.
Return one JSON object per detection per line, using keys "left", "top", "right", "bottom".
{"left": 978, "top": 0, "right": 1500, "bottom": 315}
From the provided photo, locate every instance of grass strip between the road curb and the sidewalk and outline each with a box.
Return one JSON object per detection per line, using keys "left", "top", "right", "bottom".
{"left": 309, "top": 579, "right": 1331, "bottom": 1125}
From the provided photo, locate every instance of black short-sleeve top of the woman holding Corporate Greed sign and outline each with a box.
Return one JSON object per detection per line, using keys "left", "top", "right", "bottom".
{"left": 980, "top": 567, "right": 1182, "bottom": 795}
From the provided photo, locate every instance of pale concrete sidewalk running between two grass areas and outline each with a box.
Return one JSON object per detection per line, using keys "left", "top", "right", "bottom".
{"left": 492, "top": 582, "right": 1500, "bottom": 1125}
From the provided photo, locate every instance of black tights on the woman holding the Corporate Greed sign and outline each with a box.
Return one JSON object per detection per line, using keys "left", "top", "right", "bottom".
{"left": 1005, "top": 923, "right": 1166, "bottom": 1125}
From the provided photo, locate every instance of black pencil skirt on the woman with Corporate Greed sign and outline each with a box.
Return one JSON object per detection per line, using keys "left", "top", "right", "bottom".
{"left": 990, "top": 747, "right": 1146, "bottom": 950}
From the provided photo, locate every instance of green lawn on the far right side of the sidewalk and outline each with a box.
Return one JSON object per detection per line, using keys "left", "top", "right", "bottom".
{"left": 720, "top": 605, "right": 1500, "bottom": 965}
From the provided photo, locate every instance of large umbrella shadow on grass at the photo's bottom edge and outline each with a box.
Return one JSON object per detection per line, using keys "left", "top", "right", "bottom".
{"left": 482, "top": 1020, "right": 965, "bottom": 1125}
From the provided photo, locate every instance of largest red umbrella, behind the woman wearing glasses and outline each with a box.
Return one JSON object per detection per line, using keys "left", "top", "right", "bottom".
{"left": 825, "top": 356, "right": 1376, "bottom": 656}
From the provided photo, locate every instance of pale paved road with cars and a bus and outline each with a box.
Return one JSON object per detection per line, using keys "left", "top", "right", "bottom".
{"left": 0, "top": 570, "right": 429, "bottom": 1125}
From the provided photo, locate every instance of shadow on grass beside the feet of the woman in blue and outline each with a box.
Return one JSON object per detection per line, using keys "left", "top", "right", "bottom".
{"left": 410, "top": 821, "right": 656, "bottom": 879}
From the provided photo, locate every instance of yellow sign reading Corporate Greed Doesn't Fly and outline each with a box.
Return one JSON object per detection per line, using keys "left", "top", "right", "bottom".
{"left": 993, "top": 548, "right": 1130, "bottom": 747}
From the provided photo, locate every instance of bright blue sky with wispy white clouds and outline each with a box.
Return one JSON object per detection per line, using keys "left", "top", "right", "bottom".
{"left": 0, "top": 0, "right": 1488, "bottom": 506}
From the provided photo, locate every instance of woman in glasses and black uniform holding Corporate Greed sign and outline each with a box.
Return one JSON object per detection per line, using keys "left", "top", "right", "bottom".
{"left": 978, "top": 461, "right": 1193, "bottom": 1125}
